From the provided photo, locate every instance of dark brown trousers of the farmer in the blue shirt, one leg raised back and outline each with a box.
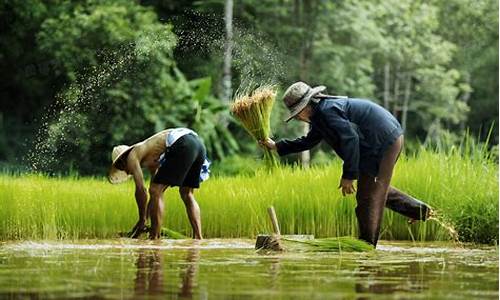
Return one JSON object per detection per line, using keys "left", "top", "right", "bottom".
{"left": 356, "top": 136, "right": 430, "bottom": 246}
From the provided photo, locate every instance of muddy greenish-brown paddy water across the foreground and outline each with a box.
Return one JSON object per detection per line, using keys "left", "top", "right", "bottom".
{"left": 0, "top": 239, "right": 498, "bottom": 299}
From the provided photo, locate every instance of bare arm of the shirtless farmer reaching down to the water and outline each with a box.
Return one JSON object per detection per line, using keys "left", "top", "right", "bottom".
{"left": 127, "top": 157, "right": 148, "bottom": 237}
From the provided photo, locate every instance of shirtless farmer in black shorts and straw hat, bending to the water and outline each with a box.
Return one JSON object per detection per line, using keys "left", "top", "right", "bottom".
{"left": 108, "top": 128, "right": 209, "bottom": 239}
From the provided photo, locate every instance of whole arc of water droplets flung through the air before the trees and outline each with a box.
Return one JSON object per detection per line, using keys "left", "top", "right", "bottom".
{"left": 25, "top": 12, "right": 285, "bottom": 173}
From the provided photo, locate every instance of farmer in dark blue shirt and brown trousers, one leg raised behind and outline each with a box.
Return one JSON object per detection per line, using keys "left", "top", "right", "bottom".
{"left": 260, "top": 82, "right": 431, "bottom": 246}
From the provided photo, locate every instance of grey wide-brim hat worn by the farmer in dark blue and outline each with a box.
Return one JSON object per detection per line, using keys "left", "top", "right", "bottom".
{"left": 283, "top": 81, "right": 326, "bottom": 122}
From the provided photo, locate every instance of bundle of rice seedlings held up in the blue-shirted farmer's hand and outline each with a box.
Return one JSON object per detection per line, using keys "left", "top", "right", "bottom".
{"left": 231, "top": 86, "right": 279, "bottom": 168}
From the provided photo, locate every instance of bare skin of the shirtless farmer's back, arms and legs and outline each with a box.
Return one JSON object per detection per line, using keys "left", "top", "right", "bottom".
{"left": 115, "top": 130, "right": 203, "bottom": 239}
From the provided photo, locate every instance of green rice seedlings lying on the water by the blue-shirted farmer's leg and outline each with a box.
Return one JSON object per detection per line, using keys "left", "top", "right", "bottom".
{"left": 284, "top": 236, "right": 374, "bottom": 252}
